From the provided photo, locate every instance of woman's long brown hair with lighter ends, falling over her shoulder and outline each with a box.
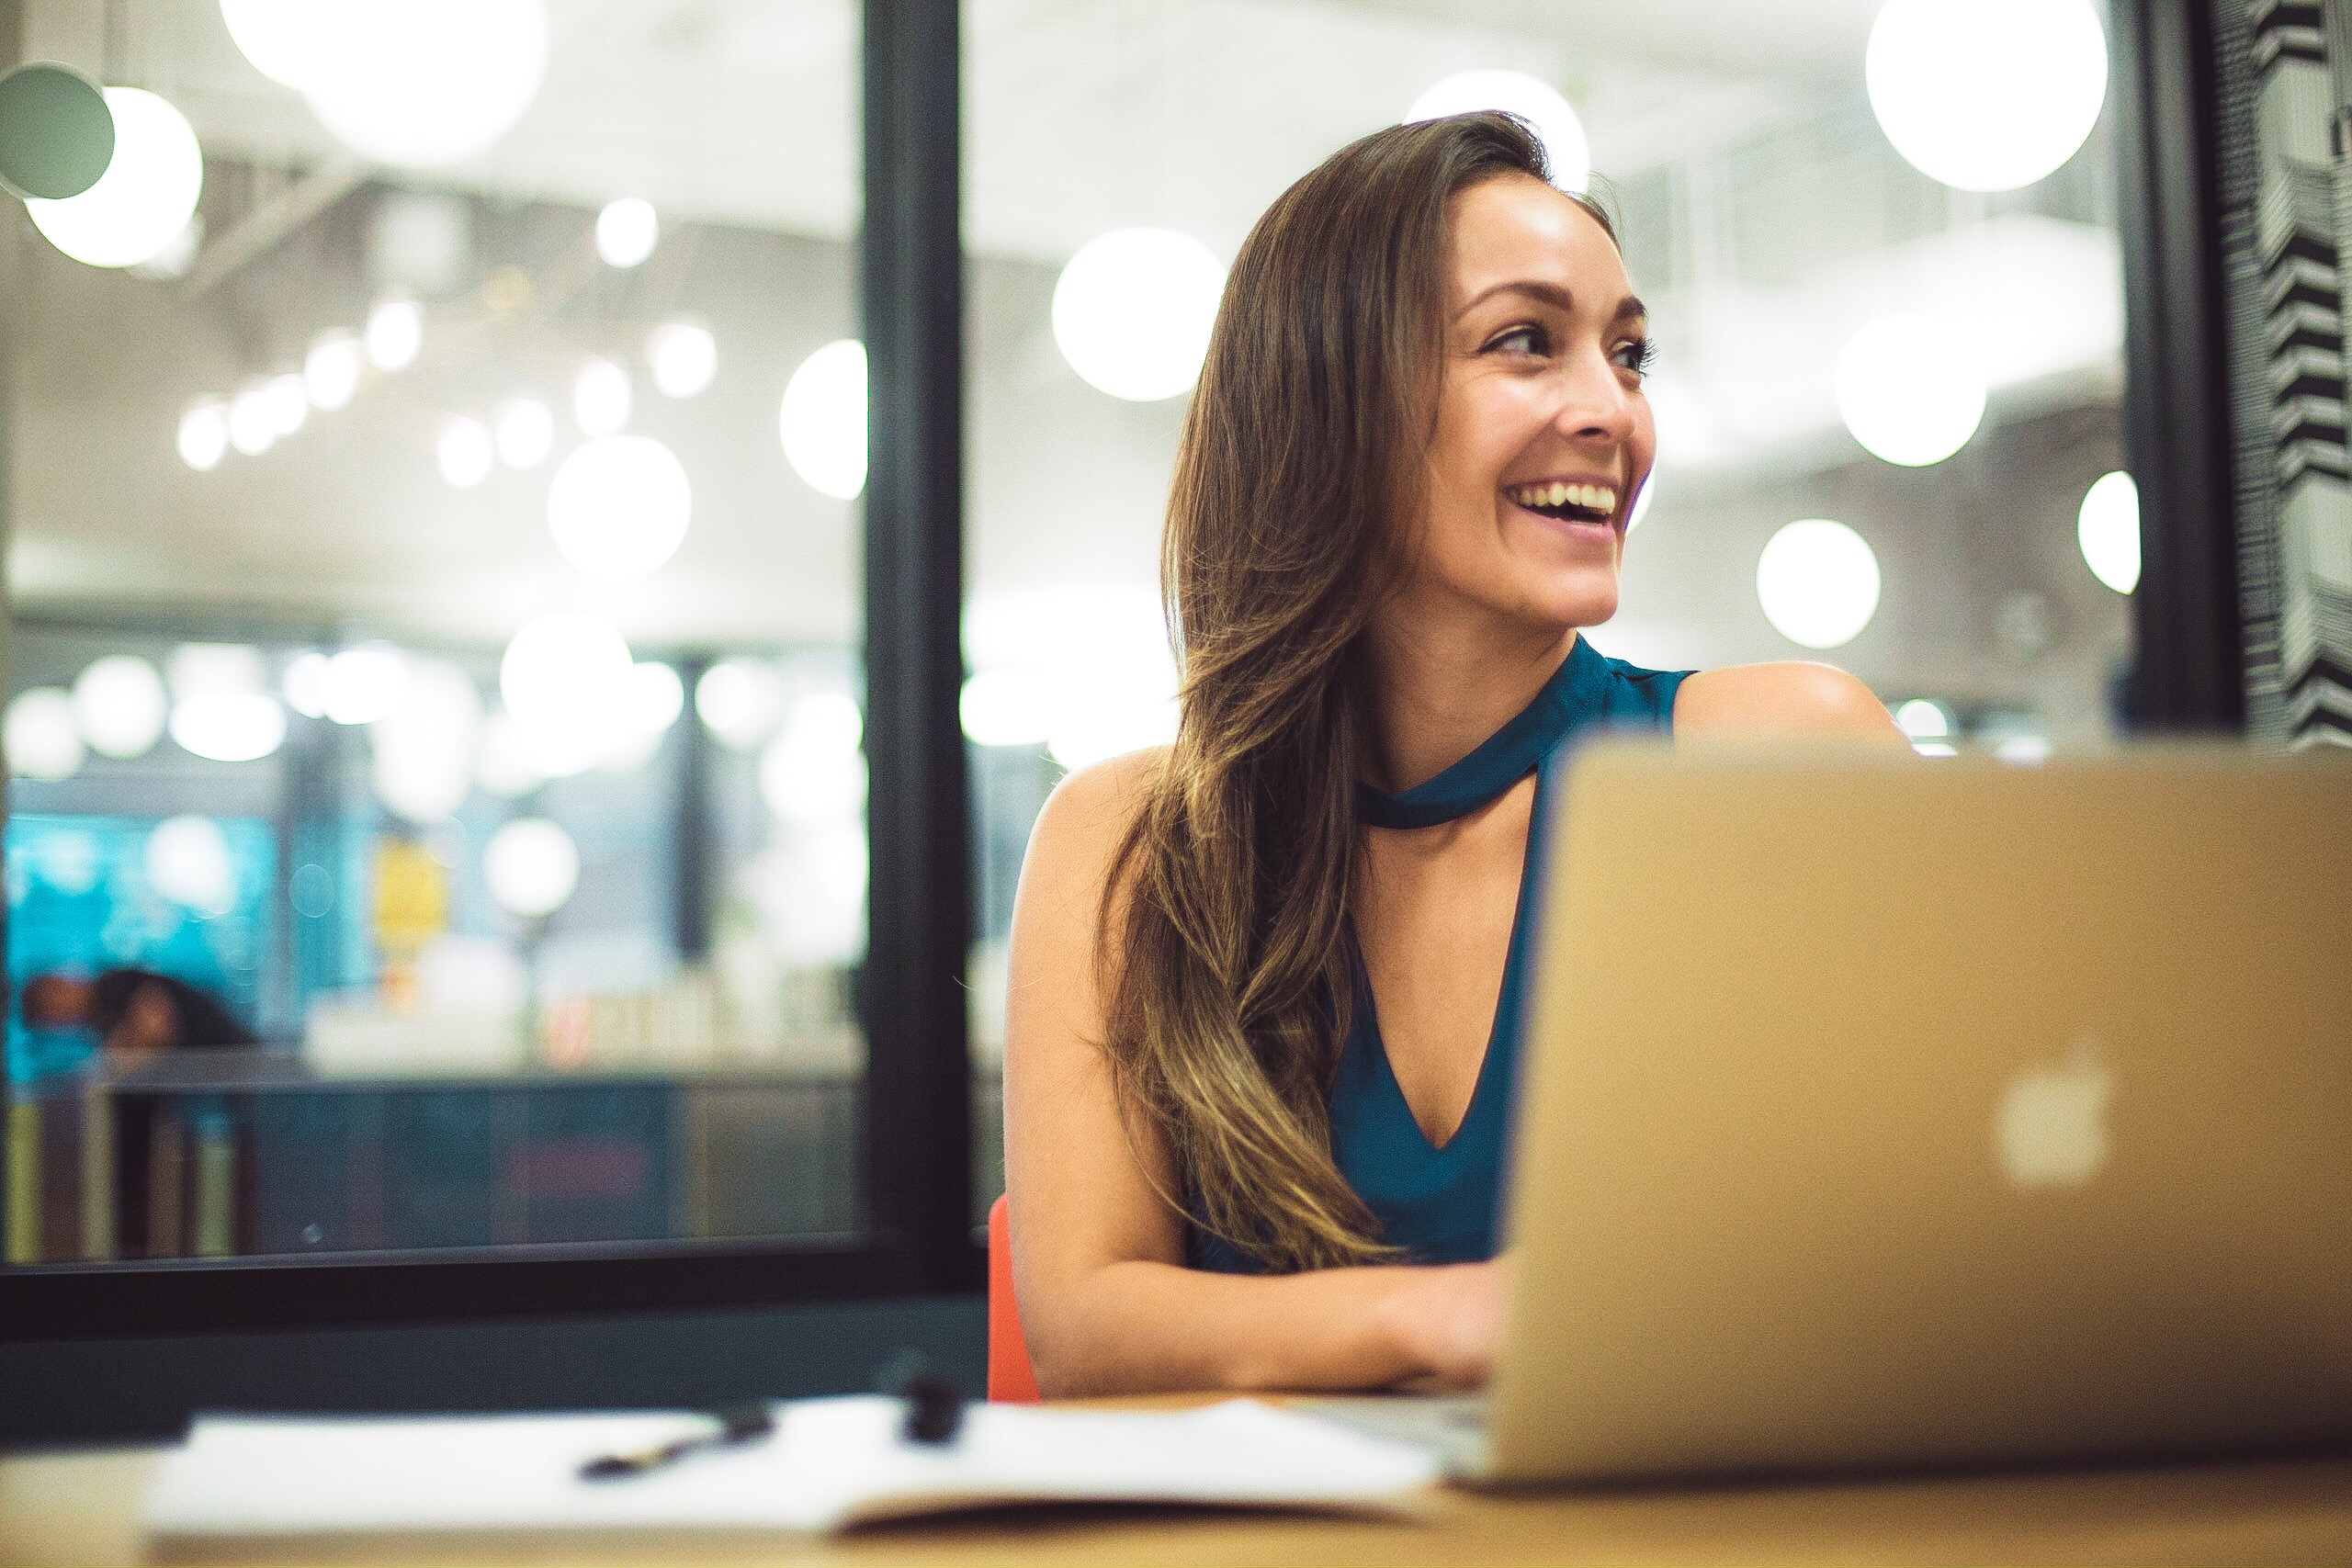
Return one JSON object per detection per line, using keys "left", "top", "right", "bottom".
{"left": 1101, "top": 113, "right": 1589, "bottom": 1269}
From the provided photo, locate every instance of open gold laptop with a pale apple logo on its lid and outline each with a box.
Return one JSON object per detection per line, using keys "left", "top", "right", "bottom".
{"left": 1317, "top": 748, "right": 2352, "bottom": 1483}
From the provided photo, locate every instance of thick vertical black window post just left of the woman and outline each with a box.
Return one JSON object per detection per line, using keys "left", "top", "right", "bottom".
{"left": 858, "top": 0, "right": 978, "bottom": 1288}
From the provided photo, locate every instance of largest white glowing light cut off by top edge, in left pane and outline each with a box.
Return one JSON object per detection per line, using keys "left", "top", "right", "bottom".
{"left": 287, "top": 0, "right": 548, "bottom": 169}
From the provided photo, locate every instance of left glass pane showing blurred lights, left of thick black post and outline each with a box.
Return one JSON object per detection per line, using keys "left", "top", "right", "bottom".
{"left": 0, "top": 0, "right": 865, "bottom": 1267}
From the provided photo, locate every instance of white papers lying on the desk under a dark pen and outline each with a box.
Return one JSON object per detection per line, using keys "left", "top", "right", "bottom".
{"left": 143, "top": 1396, "right": 1437, "bottom": 1538}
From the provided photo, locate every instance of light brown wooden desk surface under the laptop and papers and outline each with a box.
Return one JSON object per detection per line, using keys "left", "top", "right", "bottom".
{"left": 0, "top": 1448, "right": 2352, "bottom": 1568}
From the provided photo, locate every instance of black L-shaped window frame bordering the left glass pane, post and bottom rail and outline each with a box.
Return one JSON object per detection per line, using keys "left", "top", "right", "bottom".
{"left": 0, "top": 0, "right": 983, "bottom": 1342}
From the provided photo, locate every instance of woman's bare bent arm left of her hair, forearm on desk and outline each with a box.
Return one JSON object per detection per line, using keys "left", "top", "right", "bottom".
{"left": 1004, "top": 752, "right": 1500, "bottom": 1396}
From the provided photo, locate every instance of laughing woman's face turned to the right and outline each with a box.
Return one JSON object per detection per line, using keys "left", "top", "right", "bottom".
{"left": 1407, "top": 174, "right": 1656, "bottom": 630}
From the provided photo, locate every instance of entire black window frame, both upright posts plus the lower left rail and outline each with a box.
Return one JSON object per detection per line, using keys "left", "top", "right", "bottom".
{"left": 0, "top": 0, "right": 2244, "bottom": 1342}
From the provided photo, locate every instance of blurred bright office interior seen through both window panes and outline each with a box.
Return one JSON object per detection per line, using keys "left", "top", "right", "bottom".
{"left": 0, "top": 0, "right": 2138, "bottom": 1265}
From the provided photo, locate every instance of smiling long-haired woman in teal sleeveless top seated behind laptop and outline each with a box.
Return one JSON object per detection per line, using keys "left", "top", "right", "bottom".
{"left": 1007, "top": 115, "right": 1900, "bottom": 1394}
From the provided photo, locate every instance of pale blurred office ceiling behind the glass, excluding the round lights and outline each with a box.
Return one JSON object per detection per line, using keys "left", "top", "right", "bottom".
{"left": 0, "top": 0, "right": 2117, "bottom": 724}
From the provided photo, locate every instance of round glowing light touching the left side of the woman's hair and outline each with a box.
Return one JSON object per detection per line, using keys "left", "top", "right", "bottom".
{"left": 1054, "top": 228, "right": 1226, "bottom": 402}
